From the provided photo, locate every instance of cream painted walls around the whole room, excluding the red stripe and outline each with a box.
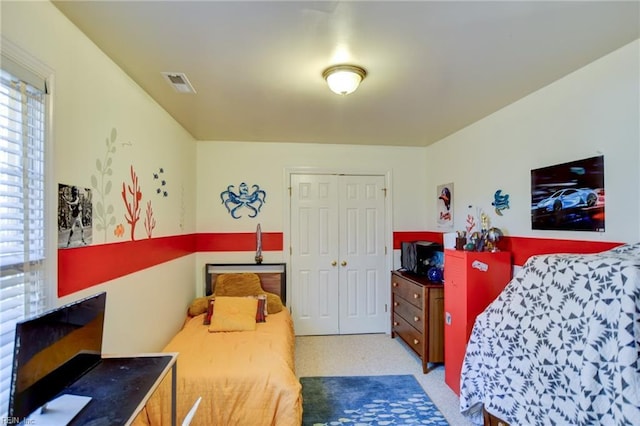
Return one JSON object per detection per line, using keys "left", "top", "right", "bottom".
{"left": 1, "top": 2, "right": 640, "bottom": 352}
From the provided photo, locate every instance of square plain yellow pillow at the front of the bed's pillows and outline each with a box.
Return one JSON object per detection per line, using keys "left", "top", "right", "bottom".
{"left": 209, "top": 296, "right": 258, "bottom": 332}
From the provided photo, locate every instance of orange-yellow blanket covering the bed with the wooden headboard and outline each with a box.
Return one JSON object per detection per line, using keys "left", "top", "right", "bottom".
{"left": 135, "top": 309, "right": 302, "bottom": 426}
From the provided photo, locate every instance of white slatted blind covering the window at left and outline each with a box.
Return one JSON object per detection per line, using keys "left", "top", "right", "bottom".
{"left": 0, "top": 56, "right": 47, "bottom": 418}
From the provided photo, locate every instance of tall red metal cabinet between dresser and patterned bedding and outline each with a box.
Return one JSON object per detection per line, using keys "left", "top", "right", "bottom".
{"left": 444, "top": 249, "right": 511, "bottom": 395}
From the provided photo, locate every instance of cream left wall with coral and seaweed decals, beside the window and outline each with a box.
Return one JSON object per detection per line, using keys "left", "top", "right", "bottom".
{"left": 1, "top": 1, "right": 195, "bottom": 352}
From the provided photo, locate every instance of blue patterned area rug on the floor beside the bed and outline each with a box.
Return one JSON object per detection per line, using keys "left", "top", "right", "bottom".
{"left": 300, "top": 375, "right": 448, "bottom": 426}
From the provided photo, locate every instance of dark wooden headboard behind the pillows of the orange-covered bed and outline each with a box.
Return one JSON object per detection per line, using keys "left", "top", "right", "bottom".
{"left": 204, "top": 263, "right": 287, "bottom": 305}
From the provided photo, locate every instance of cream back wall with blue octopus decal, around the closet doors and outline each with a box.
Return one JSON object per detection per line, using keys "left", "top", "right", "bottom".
{"left": 196, "top": 141, "right": 427, "bottom": 292}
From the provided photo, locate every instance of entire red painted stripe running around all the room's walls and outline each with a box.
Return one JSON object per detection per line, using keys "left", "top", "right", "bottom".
{"left": 58, "top": 231, "right": 622, "bottom": 297}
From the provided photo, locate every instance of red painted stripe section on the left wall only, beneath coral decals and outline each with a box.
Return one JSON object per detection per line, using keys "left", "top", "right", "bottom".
{"left": 58, "top": 234, "right": 196, "bottom": 297}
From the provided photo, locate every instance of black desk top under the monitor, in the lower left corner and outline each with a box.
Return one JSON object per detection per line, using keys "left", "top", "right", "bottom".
{"left": 60, "top": 354, "right": 175, "bottom": 426}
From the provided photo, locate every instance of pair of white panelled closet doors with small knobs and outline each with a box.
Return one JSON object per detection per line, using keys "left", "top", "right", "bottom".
{"left": 291, "top": 175, "right": 389, "bottom": 335}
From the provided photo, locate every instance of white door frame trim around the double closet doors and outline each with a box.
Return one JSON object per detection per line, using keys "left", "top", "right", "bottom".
{"left": 282, "top": 167, "right": 393, "bottom": 334}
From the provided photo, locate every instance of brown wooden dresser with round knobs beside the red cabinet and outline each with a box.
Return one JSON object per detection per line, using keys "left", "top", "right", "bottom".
{"left": 391, "top": 271, "right": 444, "bottom": 373}
